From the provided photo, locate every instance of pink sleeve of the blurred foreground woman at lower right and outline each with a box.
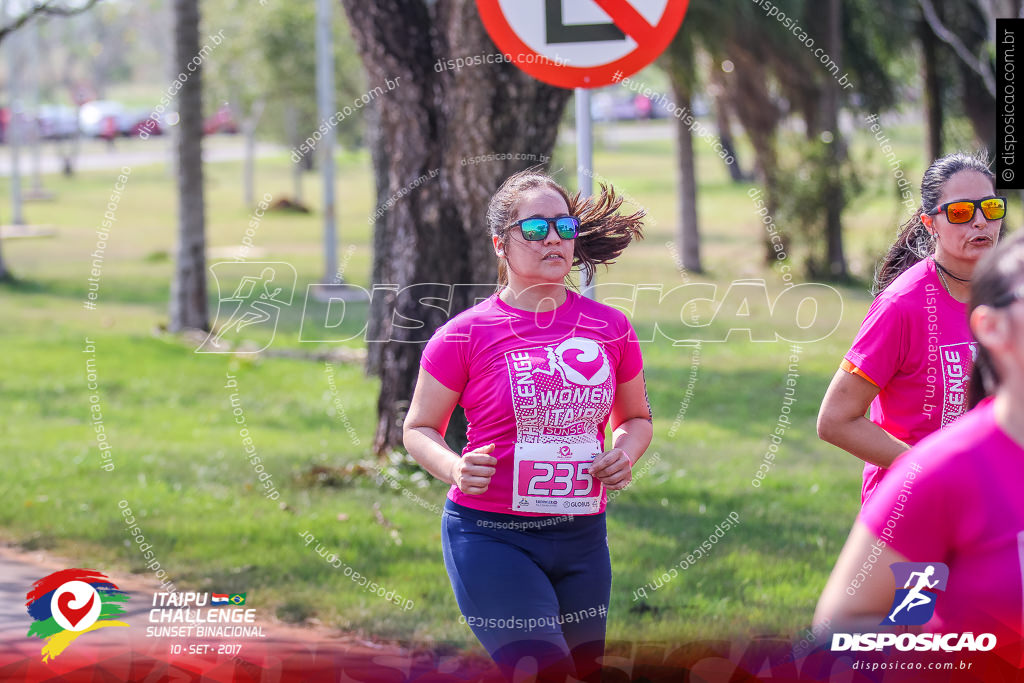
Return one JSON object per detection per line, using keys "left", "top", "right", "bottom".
{"left": 858, "top": 449, "right": 961, "bottom": 562}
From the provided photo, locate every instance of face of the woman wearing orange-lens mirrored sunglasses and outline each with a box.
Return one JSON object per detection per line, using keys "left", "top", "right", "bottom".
{"left": 922, "top": 171, "right": 1002, "bottom": 263}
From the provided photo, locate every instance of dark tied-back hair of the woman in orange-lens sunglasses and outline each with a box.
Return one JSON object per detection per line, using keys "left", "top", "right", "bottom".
{"left": 873, "top": 152, "right": 995, "bottom": 296}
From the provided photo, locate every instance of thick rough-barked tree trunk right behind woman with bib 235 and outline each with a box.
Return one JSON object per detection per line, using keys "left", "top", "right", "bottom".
{"left": 342, "top": 0, "right": 570, "bottom": 455}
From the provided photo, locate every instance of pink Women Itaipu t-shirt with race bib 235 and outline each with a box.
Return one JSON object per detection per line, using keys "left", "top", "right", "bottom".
{"left": 420, "top": 291, "right": 643, "bottom": 516}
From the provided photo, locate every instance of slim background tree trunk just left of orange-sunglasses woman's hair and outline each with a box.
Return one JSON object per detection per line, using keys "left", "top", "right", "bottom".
{"left": 821, "top": 0, "right": 848, "bottom": 280}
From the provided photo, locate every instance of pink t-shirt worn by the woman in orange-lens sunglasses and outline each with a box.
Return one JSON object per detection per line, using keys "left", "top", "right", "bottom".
{"left": 846, "top": 258, "right": 974, "bottom": 503}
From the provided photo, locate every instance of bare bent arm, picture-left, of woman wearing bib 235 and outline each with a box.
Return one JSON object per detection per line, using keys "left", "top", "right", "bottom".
{"left": 402, "top": 368, "right": 498, "bottom": 496}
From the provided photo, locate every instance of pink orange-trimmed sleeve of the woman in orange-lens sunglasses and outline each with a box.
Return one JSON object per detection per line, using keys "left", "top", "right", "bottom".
{"left": 846, "top": 297, "right": 906, "bottom": 388}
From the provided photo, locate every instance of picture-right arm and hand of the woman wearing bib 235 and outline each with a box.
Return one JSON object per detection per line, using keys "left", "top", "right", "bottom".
{"left": 590, "top": 371, "right": 654, "bottom": 490}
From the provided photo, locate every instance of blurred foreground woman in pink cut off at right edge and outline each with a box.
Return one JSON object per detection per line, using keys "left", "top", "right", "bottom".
{"left": 815, "top": 233, "right": 1024, "bottom": 643}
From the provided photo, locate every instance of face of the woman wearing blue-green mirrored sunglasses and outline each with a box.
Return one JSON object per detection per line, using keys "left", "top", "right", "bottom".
{"left": 494, "top": 186, "right": 575, "bottom": 289}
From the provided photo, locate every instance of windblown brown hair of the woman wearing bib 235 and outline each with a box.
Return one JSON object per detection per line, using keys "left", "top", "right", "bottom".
{"left": 487, "top": 167, "right": 645, "bottom": 287}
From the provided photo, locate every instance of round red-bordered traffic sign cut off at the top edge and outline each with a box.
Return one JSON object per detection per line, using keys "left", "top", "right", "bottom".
{"left": 476, "top": 0, "right": 689, "bottom": 88}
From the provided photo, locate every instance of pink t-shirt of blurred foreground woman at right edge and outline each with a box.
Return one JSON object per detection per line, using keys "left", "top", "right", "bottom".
{"left": 859, "top": 399, "right": 1024, "bottom": 645}
